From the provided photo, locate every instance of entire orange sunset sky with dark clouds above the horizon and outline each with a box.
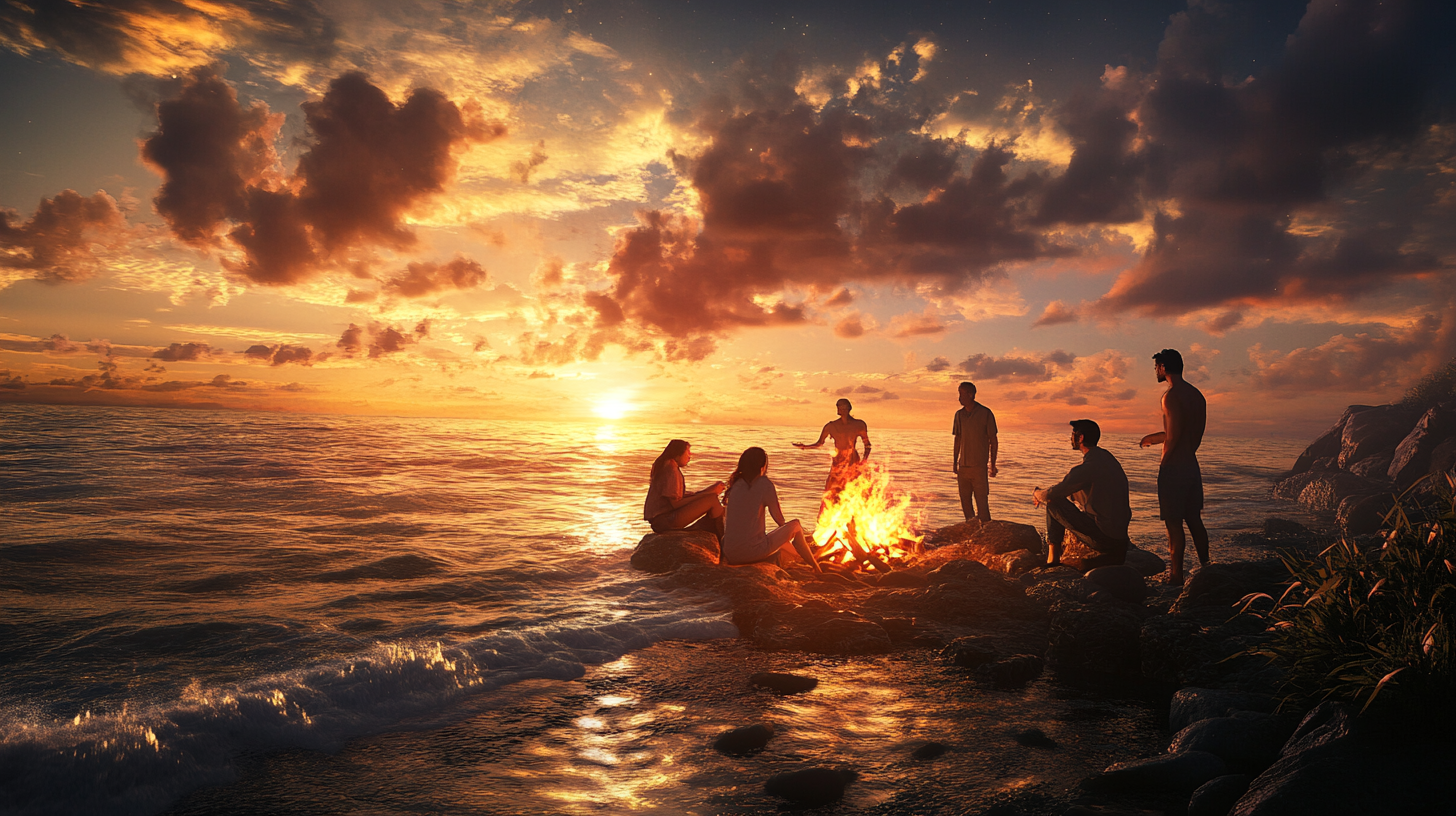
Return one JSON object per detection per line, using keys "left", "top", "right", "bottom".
{"left": 0, "top": 0, "right": 1456, "bottom": 437}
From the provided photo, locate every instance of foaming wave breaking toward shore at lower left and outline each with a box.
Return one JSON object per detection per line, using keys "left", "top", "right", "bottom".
{"left": 0, "top": 612, "right": 737, "bottom": 816}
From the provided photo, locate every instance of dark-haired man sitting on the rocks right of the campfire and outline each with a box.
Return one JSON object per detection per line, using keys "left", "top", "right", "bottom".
{"left": 1031, "top": 420, "right": 1133, "bottom": 570}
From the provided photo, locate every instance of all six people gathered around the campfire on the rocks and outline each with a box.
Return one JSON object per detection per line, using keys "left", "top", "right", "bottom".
{"left": 642, "top": 348, "right": 1208, "bottom": 584}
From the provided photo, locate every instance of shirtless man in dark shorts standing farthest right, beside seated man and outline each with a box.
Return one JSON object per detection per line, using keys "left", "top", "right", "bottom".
{"left": 1142, "top": 348, "right": 1208, "bottom": 586}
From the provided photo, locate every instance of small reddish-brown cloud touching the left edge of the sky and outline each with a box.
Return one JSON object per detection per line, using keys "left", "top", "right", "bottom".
{"left": 0, "top": 189, "right": 125, "bottom": 284}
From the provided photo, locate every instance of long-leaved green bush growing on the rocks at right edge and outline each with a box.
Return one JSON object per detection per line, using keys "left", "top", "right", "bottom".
{"left": 1245, "top": 480, "right": 1456, "bottom": 727}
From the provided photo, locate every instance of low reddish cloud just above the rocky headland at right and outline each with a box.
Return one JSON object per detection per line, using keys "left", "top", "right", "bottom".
{"left": 1249, "top": 315, "right": 1440, "bottom": 398}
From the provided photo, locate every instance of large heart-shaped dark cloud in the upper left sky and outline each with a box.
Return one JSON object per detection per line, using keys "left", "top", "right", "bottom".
{"left": 141, "top": 68, "right": 505, "bottom": 284}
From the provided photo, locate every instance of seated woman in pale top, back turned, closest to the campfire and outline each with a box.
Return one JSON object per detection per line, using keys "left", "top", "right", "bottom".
{"left": 722, "top": 447, "right": 823, "bottom": 573}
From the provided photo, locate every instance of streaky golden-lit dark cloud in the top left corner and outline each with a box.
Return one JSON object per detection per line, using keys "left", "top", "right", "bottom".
{"left": 0, "top": 0, "right": 336, "bottom": 76}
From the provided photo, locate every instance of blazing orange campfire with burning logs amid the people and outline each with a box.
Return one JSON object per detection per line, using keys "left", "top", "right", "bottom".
{"left": 814, "top": 462, "right": 925, "bottom": 573}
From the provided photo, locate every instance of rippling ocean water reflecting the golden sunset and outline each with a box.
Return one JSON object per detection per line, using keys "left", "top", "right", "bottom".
{"left": 0, "top": 405, "right": 1322, "bottom": 815}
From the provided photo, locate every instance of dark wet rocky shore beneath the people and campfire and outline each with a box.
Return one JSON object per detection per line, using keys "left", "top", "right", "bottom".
{"left": 632, "top": 504, "right": 1456, "bottom": 816}
